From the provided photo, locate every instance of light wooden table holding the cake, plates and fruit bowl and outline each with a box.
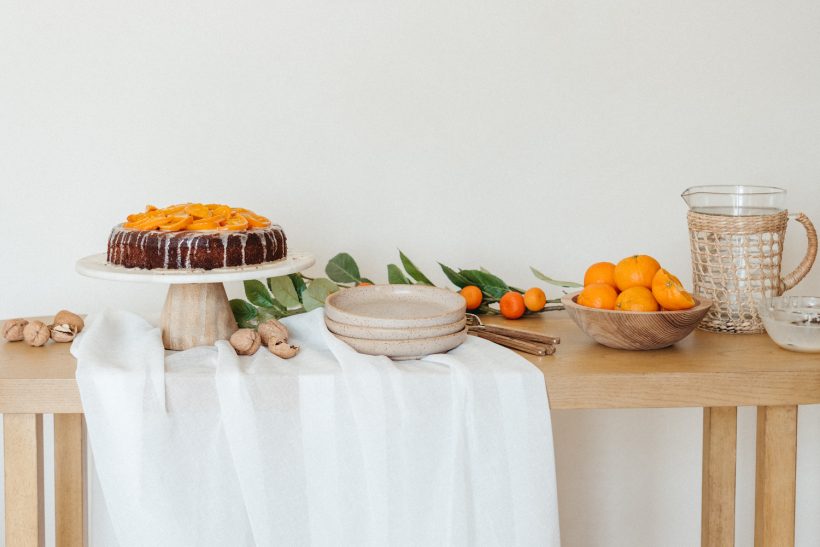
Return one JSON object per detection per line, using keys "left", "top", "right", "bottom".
{"left": 0, "top": 312, "right": 820, "bottom": 547}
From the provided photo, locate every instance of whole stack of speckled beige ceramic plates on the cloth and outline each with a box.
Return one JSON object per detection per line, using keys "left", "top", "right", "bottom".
{"left": 325, "top": 285, "right": 467, "bottom": 359}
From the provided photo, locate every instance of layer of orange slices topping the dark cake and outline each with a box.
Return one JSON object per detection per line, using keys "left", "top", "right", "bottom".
{"left": 123, "top": 203, "right": 270, "bottom": 232}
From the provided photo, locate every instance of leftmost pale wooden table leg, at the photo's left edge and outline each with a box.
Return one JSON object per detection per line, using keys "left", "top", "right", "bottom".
{"left": 3, "top": 414, "right": 45, "bottom": 547}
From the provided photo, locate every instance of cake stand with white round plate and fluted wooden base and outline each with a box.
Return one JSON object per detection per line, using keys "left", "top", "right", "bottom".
{"left": 77, "top": 251, "right": 316, "bottom": 350}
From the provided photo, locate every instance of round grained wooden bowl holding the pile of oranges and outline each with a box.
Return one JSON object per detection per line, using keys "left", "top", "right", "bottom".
{"left": 561, "top": 292, "right": 712, "bottom": 350}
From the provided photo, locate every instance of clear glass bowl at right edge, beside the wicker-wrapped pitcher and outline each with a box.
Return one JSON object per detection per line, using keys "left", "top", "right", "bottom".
{"left": 757, "top": 296, "right": 820, "bottom": 353}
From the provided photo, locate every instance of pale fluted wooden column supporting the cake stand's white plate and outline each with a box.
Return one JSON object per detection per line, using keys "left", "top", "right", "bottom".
{"left": 160, "top": 283, "right": 238, "bottom": 350}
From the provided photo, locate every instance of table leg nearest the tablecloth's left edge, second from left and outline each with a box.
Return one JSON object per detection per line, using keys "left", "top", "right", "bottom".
{"left": 54, "top": 414, "right": 85, "bottom": 547}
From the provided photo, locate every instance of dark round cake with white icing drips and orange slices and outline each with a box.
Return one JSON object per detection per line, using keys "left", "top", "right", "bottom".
{"left": 108, "top": 203, "right": 287, "bottom": 270}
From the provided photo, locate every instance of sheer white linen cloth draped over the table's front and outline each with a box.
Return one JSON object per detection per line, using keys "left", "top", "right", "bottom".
{"left": 71, "top": 310, "right": 560, "bottom": 547}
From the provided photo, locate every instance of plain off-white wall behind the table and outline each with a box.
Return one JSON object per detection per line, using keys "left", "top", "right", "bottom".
{"left": 0, "top": 0, "right": 820, "bottom": 547}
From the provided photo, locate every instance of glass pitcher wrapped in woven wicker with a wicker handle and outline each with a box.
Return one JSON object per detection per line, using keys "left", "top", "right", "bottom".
{"left": 681, "top": 185, "right": 817, "bottom": 333}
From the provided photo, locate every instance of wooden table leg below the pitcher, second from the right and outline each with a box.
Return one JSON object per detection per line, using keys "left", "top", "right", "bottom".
{"left": 700, "top": 406, "right": 737, "bottom": 547}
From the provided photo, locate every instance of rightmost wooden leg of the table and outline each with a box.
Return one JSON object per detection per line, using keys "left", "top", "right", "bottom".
{"left": 755, "top": 406, "right": 797, "bottom": 547}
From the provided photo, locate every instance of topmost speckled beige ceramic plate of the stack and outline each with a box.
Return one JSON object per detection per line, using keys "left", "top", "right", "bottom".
{"left": 325, "top": 285, "right": 466, "bottom": 329}
